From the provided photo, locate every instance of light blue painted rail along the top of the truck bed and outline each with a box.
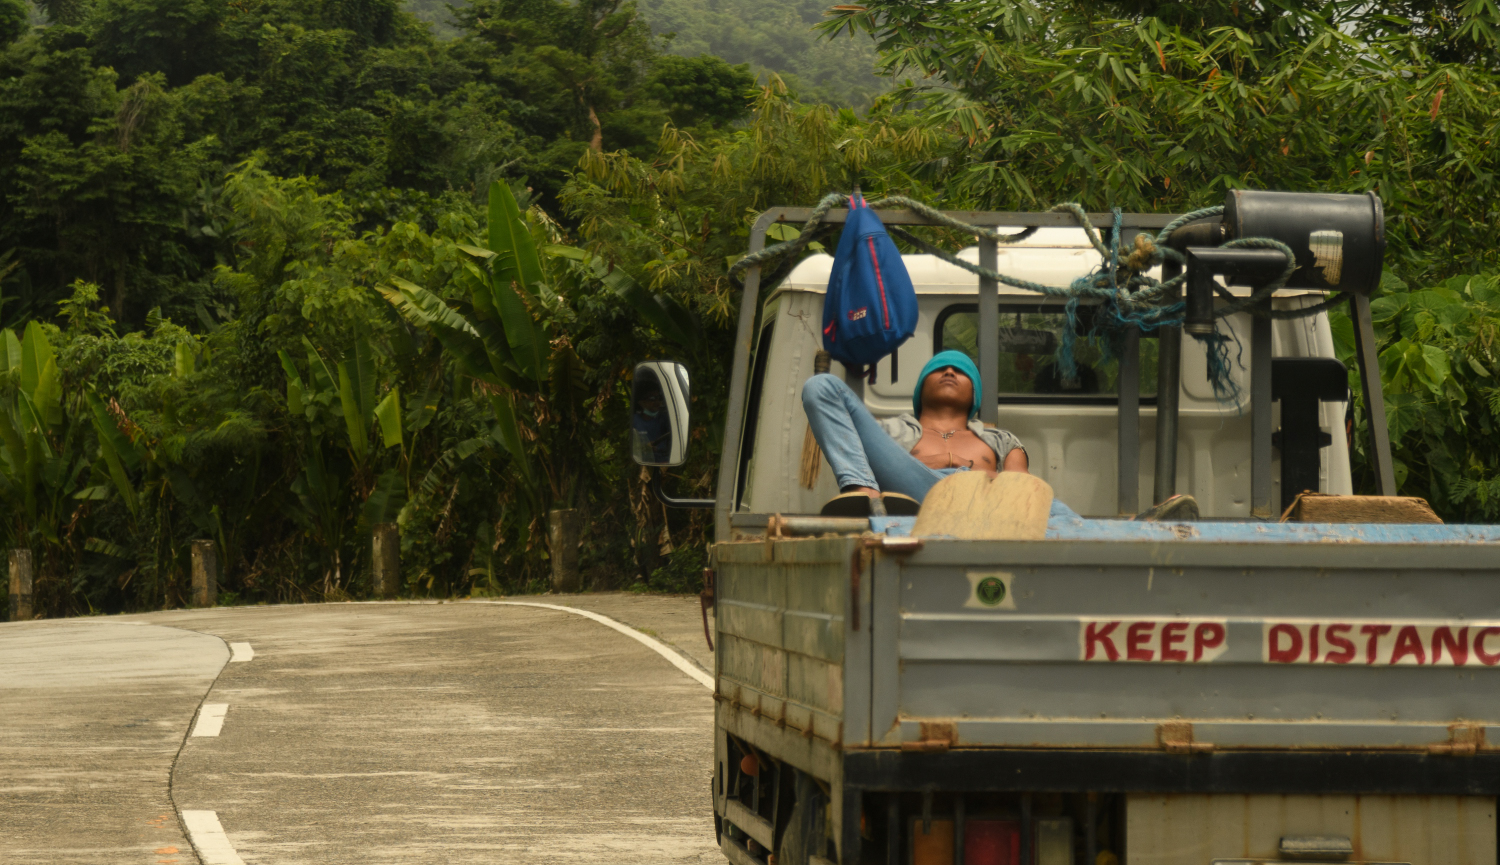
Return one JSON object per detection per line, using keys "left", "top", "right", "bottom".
{"left": 870, "top": 501, "right": 1500, "bottom": 544}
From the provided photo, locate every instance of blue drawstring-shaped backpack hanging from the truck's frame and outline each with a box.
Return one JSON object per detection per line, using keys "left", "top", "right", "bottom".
{"left": 824, "top": 192, "right": 917, "bottom": 368}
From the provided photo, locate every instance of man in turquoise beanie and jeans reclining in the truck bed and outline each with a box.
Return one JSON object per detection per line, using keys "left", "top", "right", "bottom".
{"left": 803, "top": 351, "right": 1029, "bottom": 516}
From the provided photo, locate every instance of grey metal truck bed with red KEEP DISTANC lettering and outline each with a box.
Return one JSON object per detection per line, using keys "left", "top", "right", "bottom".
{"left": 714, "top": 523, "right": 1500, "bottom": 863}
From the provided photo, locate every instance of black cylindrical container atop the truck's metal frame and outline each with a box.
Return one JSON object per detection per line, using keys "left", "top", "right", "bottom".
{"left": 1224, "top": 189, "right": 1386, "bottom": 295}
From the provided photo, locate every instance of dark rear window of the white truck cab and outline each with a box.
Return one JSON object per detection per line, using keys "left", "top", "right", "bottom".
{"left": 933, "top": 303, "right": 1157, "bottom": 403}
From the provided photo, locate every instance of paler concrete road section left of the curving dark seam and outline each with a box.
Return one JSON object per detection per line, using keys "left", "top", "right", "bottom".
{"left": 0, "top": 619, "right": 230, "bottom": 865}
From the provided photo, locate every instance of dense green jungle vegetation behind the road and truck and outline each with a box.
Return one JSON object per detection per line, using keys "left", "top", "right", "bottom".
{"left": 0, "top": 0, "right": 1500, "bottom": 615}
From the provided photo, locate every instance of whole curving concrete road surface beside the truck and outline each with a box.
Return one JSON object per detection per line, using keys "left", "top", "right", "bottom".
{"left": 0, "top": 595, "right": 723, "bottom": 865}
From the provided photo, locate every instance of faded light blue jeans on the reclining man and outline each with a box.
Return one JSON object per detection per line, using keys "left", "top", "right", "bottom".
{"left": 803, "top": 373, "right": 969, "bottom": 501}
